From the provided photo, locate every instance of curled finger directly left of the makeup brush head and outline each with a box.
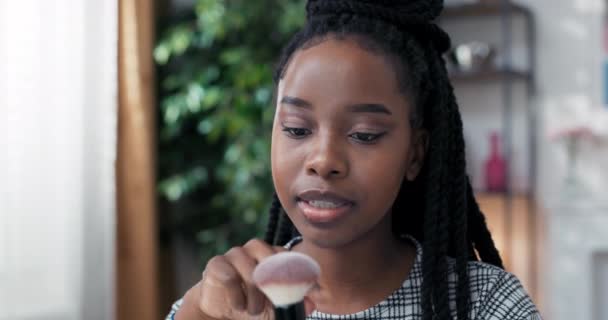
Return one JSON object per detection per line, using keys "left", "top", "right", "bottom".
{"left": 226, "top": 247, "right": 266, "bottom": 316}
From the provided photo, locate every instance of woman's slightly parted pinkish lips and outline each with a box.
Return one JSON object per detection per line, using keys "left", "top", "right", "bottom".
{"left": 297, "top": 189, "right": 354, "bottom": 223}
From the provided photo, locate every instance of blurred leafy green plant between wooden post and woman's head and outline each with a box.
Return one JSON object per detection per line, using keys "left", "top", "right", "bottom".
{"left": 154, "top": 0, "right": 304, "bottom": 262}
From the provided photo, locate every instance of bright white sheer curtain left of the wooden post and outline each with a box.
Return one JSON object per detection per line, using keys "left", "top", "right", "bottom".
{"left": 0, "top": 0, "right": 117, "bottom": 320}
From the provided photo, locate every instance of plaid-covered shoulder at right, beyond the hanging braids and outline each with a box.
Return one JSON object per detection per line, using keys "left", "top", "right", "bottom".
{"left": 450, "top": 261, "right": 540, "bottom": 320}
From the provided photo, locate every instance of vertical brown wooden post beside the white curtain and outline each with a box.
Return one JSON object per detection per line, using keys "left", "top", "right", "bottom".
{"left": 116, "top": 0, "right": 159, "bottom": 320}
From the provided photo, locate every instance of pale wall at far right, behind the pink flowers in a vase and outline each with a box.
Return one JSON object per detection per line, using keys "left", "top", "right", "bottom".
{"left": 525, "top": 0, "right": 608, "bottom": 202}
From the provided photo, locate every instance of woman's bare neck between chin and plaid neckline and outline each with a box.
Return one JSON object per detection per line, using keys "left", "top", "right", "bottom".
{"left": 293, "top": 218, "right": 416, "bottom": 313}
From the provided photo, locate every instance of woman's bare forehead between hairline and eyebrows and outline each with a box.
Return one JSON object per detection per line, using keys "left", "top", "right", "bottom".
{"left": 279, "top": 38, "right": 403, "bottom": 102}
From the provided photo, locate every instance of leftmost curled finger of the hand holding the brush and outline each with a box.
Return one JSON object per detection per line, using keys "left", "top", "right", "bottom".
{"left": 202, "top": 256, "right": 246, "bottom": 311}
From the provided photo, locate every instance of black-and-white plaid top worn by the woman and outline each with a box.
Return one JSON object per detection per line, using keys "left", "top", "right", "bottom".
{"left": 166, "top": 237, "right": 541, "bottom": 320}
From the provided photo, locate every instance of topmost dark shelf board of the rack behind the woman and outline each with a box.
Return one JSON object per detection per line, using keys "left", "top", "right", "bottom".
{"left": 440, "top": 0, "right": 532, "bottom": 19}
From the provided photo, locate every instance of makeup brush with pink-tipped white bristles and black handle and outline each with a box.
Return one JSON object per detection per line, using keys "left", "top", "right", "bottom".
{"left": 253, "top": 252, "right": 321, "bottom": 320}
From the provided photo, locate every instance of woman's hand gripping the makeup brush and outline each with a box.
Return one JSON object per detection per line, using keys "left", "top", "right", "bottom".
{"left": 175, "top": 239, "right": 318, "bottom": 320}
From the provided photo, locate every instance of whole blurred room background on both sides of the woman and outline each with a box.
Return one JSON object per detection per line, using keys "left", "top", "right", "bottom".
{"left": 0, "top": 0, "right": 608, "bottom": 320}
